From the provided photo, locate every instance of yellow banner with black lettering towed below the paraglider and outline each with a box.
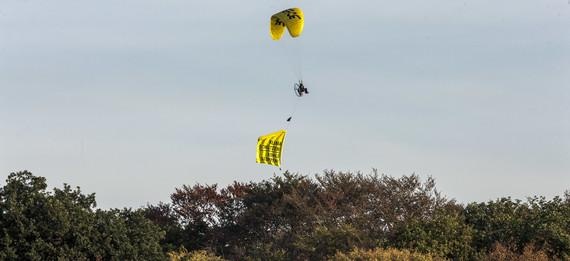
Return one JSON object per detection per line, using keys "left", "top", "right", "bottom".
{"left": 255, "top": 130, "right": 287, "bottom": 167}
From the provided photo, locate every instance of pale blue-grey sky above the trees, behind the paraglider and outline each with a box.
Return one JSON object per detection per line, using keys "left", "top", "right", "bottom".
{"left": 0, "top": 0, "right": 570, "bottom": 208}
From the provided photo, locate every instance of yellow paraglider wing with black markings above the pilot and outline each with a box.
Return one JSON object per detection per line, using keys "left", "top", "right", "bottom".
{"left": 270, "top": 7, "right": 305, "bottom": 40}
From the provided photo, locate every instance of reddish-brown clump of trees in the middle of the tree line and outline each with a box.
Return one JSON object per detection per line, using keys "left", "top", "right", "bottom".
{"left": 147, "top": 171, "right": 450, "bottom": 260}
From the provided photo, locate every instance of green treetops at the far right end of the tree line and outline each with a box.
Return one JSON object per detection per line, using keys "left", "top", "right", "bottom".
{"left": 464, "top": 197, "right": 570, "bottom": 259}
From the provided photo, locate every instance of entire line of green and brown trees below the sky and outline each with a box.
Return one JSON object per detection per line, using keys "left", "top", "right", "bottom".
{"left": 0, "top": 171, "right": 570, "bottom": 260}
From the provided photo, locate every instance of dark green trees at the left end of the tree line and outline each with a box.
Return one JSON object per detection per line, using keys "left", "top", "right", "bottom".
{"left": 0, "top": 171, "right": 164, "bottom": 260}
